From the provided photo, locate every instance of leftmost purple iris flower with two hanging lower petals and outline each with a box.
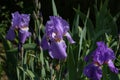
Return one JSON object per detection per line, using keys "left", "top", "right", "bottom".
{"left": 6, "top": 12, "right": 31, "bottom": 43}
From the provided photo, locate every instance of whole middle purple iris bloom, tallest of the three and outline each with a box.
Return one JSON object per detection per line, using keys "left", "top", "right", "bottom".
{"left": 41, "top": 16, "right": 75, "bottom": 59}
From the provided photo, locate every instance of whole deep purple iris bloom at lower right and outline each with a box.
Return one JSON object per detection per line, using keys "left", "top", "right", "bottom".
{"left": 84, "top": 41, "right": 119, "bottom": 80}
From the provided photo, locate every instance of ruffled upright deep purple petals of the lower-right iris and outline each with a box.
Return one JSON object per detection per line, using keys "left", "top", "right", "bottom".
{"left": 92, "top": 42, "right": 115, "bottom": 65}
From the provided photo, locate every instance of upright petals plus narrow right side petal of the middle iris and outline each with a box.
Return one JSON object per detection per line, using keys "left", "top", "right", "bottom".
{"left": 45, "top": 16, "right": 75, "bottom": 43}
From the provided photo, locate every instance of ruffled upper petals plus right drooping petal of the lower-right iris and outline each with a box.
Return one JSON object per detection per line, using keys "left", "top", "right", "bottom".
{"left": 92, "top": 42, "right": 118, "bottom": 73}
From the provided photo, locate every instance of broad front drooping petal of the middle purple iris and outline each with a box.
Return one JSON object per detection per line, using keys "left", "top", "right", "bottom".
{"left": 49, "top": 40, "right": 67, "bottom": 59}
